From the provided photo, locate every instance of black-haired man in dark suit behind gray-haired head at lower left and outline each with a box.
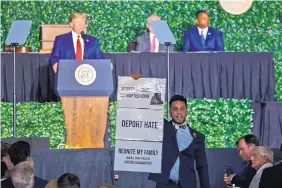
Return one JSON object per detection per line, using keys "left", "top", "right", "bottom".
{"left": 1, "top": 141, "right": 48, "bottom": 188}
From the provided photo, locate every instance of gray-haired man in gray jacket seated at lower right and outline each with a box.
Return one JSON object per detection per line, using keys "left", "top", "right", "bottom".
{"left": 249, "top": 146, "right": 273, "bottom": 188}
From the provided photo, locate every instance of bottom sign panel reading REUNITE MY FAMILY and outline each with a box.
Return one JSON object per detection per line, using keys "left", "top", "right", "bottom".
{"left": 114, "top": 140, "right": 162, "bottom": 173}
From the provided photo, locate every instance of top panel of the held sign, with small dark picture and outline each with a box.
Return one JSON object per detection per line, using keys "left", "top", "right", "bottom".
{"left": 117, "top": 77, "right": 166, "bottom": 110}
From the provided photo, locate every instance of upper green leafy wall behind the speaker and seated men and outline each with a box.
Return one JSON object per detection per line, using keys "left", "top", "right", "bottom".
{"left": 1, "top": 0, "right": 282, "bottom": 101}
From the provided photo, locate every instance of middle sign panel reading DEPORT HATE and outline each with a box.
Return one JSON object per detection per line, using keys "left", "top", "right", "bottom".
{"left": 116, "top": 108, "right": 164, "bottom": 141}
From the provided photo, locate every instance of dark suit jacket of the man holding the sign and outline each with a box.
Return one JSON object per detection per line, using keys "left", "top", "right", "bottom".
{"left": 148, "top": 120, "right": 210, "bottom": 188}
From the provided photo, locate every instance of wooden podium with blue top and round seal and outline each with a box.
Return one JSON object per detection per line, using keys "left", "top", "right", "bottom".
{"left": 55, "top": 59, "right": 114, "bottom": 148}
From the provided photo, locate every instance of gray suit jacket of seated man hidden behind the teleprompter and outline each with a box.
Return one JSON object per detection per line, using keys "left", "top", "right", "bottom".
{"left": 136, "top": 32, "right": 173, "bottom": 52}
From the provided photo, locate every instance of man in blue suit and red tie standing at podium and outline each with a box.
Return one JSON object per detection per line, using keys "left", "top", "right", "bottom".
{"left": 49, "top": 12, "right": 103, "bottom": 72}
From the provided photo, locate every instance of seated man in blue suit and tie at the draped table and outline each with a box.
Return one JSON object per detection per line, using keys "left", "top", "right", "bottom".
{"left": 182, "top": 10, "right": 224, "bottom": 52}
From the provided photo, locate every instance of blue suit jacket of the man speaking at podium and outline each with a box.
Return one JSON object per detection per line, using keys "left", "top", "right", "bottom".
{"left": 49, "top": 32, "right": 103, "bottom": 66}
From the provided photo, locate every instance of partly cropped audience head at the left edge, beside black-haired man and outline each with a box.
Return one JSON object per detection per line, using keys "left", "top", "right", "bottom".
{"left": 1, "top": 142, "right": 14, "bottom": 178}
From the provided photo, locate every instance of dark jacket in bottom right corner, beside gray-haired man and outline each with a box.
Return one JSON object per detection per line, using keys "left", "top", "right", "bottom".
{"left": 259, "top": 162, "right": 282, "bottom": 188}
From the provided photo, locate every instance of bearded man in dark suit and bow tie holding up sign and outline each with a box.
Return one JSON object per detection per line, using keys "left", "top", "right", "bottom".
{"left": 149, "top": 95, "right": 210, "bottom": 188}
